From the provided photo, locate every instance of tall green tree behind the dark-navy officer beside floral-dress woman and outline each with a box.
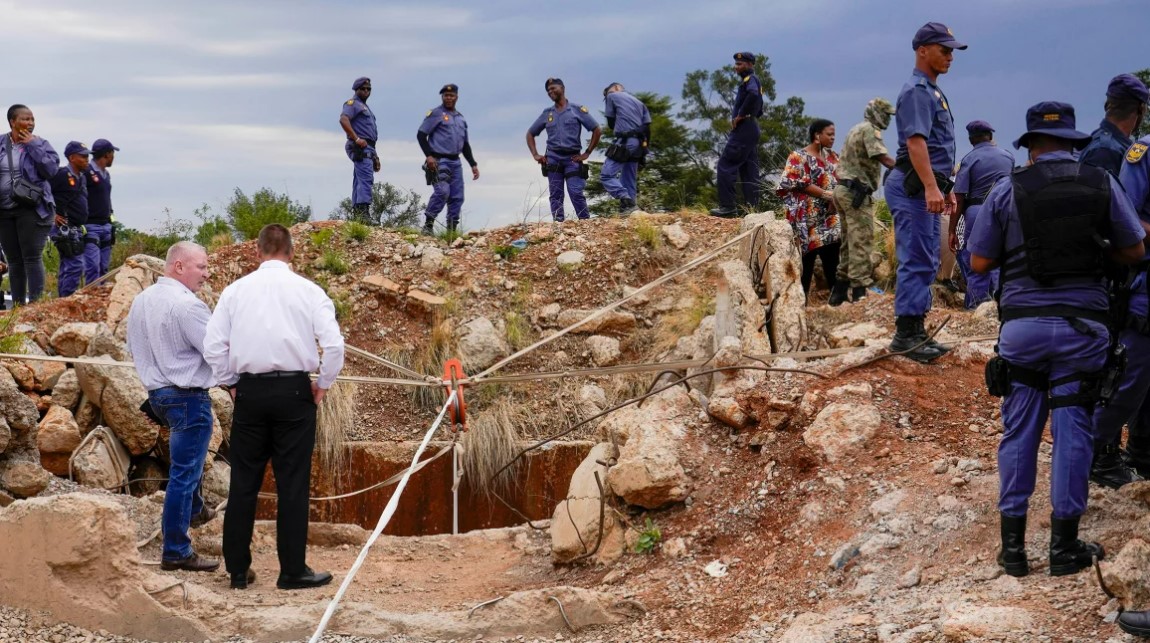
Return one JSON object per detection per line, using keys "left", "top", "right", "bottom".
{"left": 679, "top": 54, "right": 811, "bottom": 209}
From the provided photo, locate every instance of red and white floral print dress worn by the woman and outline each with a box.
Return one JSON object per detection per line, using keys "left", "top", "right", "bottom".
{"left": 776, "top": 150, "right": 843, "bottom": 254}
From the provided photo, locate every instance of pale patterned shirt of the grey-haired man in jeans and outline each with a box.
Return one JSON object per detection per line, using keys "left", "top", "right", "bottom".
{"left": 128, "top": 277, "right": 215, "bottom": 391}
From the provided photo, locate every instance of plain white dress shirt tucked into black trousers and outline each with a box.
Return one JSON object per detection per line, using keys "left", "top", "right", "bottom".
{"left": 204, "top": 259, "right": 344, "bottom": 389}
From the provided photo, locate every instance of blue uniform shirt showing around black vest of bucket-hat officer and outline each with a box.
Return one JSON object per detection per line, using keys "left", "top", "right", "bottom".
{"left": 966, "top": 152, "right": 1145, "bottom": 311}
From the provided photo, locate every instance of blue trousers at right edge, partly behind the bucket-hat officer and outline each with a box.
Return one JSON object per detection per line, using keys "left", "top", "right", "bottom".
{"left": 1094, "top": 273, "right": 1150, "bottom": 453}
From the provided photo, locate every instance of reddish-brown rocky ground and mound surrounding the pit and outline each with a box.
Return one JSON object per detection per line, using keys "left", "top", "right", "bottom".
{"left": 0, "top": 214, "right": 1150, "bottom": 643}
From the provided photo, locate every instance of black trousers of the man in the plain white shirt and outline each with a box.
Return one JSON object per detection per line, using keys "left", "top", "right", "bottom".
{"left": 223, "top": 374, "right": 316, "bottom": 575}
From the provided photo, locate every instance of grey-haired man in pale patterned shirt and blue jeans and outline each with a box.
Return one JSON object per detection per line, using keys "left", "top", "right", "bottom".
{"left": 128, "top": 242, "right": 220, "bottom": 572}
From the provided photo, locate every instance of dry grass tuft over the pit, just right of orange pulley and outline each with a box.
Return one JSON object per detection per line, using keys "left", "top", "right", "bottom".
{"left": 462, "top": 396, "right": 531, "bottom": 495}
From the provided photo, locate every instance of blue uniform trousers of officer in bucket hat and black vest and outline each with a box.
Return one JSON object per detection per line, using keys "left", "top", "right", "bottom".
{"left": 998, "top": 317, "right": 1109, "bottom": 519}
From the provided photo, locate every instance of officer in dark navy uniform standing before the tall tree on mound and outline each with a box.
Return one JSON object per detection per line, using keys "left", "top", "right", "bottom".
{"left": 711, "top": 52, "right": 762, "bottom": 219}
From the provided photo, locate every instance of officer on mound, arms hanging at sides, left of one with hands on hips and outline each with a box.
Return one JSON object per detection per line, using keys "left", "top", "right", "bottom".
{"left": 415, "top": 85, "right": 480, "bottom": 236}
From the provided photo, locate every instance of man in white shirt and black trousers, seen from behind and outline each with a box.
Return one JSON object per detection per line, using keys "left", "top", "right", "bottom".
{"left": 204, "top": 223, "right": 344, "bottom": 589}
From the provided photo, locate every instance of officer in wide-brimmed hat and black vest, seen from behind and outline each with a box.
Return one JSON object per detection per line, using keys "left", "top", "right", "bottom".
{"left": 967, "top": 102, "right": 1145, "bottom": 576}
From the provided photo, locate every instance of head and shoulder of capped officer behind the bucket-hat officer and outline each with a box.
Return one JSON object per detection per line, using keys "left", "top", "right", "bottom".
{"left": 1079, "top": 74, "right": 1150, "bottom": 176}
